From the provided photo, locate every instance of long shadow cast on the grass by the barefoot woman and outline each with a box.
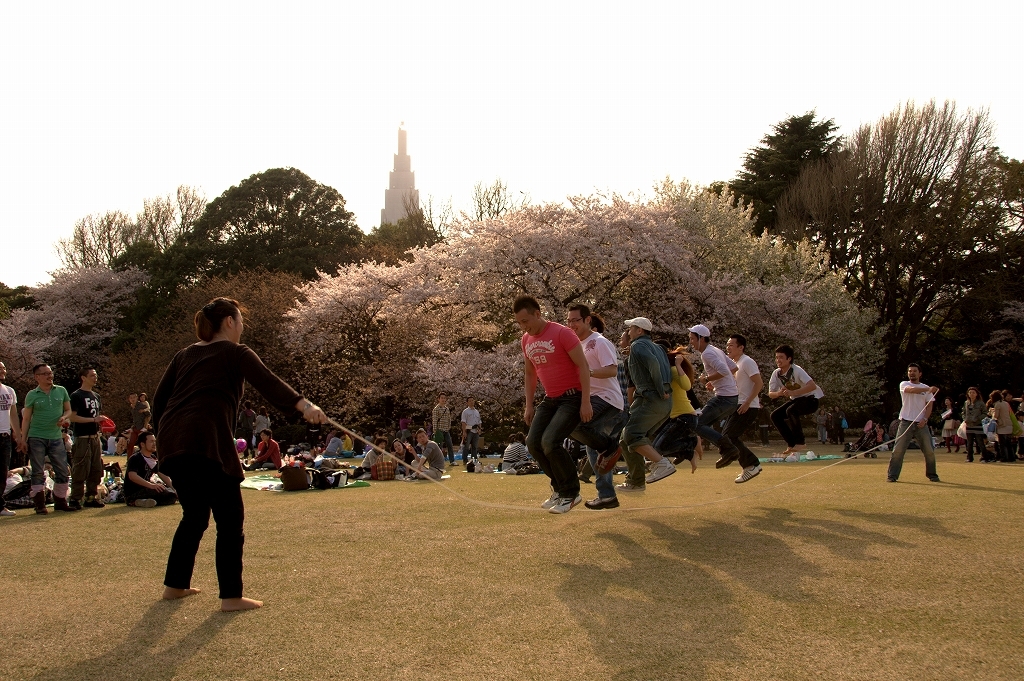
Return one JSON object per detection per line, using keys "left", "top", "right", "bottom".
{"left": 32, "top": 600, "right": 237, "bottom": 681}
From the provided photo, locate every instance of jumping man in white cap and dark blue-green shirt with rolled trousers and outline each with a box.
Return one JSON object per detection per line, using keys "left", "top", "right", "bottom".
{"left": 620, "top": 316, "right": 676, "bottom": 483}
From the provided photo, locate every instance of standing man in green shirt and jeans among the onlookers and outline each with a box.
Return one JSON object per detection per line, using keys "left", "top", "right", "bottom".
{"left": 22, "top": 365, "right": 76, "bottom": 515}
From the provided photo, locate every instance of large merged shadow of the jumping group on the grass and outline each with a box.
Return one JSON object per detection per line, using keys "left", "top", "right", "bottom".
{"left": 556, "top": 508, "right": 921, "bottom": 679}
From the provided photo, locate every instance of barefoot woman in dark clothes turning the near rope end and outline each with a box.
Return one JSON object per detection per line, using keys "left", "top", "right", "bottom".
{"left": 153, "top": 298, "right": 327, "bottom": 611}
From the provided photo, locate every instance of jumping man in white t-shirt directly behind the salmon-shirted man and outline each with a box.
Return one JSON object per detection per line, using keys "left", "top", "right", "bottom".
{"left": 565, "top": 303, "right": 626, "bottom": 510}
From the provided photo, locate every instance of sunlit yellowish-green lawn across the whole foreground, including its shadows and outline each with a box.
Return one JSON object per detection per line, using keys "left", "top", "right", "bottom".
{"left": 0, "top": 448, "right": 1024, "bottom": 681}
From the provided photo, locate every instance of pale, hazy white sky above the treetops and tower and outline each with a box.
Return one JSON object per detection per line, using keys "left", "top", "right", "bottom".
{"left": 0, "top": 0, "right": 1024, "bottom": 286}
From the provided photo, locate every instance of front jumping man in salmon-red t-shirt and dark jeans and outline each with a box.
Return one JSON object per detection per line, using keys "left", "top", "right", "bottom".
{"left": 512, "top": 296, "right": 594, "bottom": 513}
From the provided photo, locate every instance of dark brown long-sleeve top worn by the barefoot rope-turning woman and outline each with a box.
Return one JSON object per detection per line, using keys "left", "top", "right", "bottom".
{"left": 153, "top": 341, "right": 302, "bottom": 479}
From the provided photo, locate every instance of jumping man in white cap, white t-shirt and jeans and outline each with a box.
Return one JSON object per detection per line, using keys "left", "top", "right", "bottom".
{"left": 688, "top": 324, "right": 739, "bottom": 468}
